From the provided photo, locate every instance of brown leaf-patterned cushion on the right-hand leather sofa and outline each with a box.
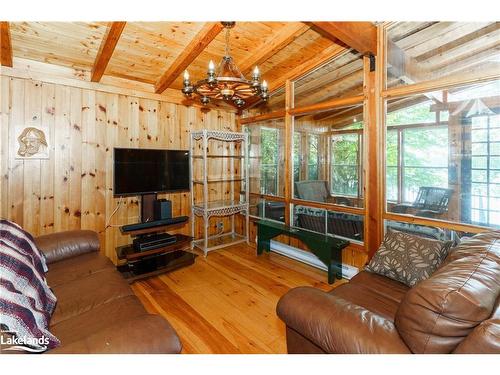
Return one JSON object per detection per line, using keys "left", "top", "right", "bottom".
{"left": 366, "top": 230, "right": 452, "bottom": 287}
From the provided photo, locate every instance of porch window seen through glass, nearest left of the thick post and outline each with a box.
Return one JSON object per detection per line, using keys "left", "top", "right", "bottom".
{"left": 330, "top": 132, "right": 361, "bottom": 197}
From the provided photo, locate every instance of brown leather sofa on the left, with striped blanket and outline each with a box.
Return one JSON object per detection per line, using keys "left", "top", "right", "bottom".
{"left": 1, "top": 231, "right": 181, "bottom": 354}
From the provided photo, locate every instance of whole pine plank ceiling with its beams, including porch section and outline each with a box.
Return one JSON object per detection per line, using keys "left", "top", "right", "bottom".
{"left": 1, "top": 22, "right": 500, "bottom": 111}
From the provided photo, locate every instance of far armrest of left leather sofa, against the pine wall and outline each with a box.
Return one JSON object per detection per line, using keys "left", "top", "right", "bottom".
{"left": 35, "top": 230, "right": 100, "bottom": 263}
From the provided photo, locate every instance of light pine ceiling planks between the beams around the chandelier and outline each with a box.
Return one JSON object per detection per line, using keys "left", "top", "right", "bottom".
{"left": 5, "top": 22, "right": 342, "bottom": 89}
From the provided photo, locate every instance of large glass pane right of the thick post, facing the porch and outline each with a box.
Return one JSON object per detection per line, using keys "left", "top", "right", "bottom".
{"left": 385, "top": 80, "right": 500, "bottom": 227}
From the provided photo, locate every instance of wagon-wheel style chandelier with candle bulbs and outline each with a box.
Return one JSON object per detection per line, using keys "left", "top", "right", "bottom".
{"left": 182, "top": 22, "right": 269, "bottom": 108}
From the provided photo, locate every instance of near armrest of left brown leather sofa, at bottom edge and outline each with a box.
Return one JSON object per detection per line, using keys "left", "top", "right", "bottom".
{"left": 48, "top": 314, "right": 182, "bottom": 354}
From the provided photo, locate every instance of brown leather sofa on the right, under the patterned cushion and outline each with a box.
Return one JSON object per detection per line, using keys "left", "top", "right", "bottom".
{"left": 277, "top": 232, "right": 500, "bottom": 354}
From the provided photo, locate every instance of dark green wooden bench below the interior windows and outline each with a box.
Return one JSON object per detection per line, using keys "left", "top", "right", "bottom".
{"left": 256, "top": 220, "right": 349, "bottom": 284}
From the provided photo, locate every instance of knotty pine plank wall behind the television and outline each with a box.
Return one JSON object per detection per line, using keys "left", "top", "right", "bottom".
{"left": 0, "top": 76, "right": 236, "bottom": 261}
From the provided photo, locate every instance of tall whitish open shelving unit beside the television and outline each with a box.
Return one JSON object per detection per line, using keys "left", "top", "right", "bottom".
{"left": 190, "top": 130, "right": 249, "bottom": 256}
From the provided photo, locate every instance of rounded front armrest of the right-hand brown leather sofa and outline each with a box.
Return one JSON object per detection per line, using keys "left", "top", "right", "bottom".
{"left": 276, "top": 287, "right": 410, "bottom": 354}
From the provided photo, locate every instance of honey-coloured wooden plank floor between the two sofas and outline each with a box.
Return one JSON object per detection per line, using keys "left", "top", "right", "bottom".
{"left": 132, "top": 245, "right": 343, "bottom": 354}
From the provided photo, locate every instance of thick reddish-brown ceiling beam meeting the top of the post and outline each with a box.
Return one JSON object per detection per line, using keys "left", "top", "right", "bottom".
{"left": 307, "top": 22, "right": 377, "bottom": 55}
